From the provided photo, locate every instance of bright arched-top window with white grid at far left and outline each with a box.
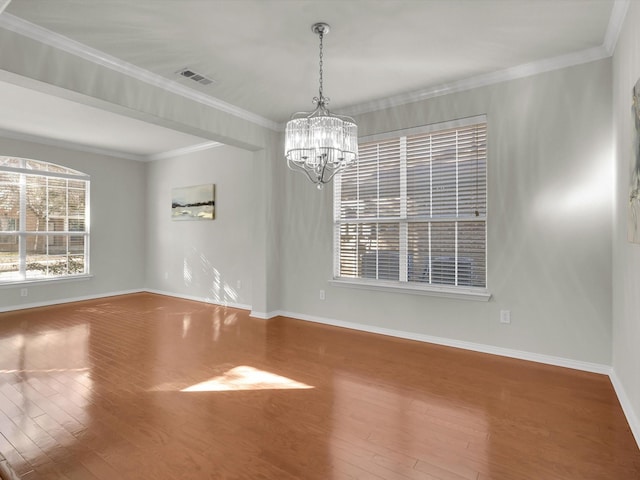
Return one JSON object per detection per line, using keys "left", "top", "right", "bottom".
{"left": 0, "top": 156, "right": 90, "bottom": 283}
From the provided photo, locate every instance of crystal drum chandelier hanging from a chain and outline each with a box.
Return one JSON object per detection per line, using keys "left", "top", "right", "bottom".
{"left": 284, "top": 23, "right": 358, "bottom": 190}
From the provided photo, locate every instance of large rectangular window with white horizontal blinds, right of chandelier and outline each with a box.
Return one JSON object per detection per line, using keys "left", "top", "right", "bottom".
{"left": 334, "top": 117, "right": 487, "bottom": 289}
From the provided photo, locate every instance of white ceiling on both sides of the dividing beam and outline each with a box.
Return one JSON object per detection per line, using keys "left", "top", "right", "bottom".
{"left": 0, "top": 0, "right": 626, "bottom": 158}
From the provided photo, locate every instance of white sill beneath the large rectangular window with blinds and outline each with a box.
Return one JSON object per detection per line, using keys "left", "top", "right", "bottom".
{"left": 329, "top": 278, "right": 491, "bottom": 302}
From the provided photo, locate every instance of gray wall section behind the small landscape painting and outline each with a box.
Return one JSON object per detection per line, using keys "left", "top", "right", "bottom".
{"left": 146, "top": 142, "right": 257, "bottom": 308}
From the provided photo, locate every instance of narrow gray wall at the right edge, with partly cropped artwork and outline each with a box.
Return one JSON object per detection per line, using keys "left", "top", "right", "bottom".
{"left": 613, "top": 2, "right": 640, "bottom": 445}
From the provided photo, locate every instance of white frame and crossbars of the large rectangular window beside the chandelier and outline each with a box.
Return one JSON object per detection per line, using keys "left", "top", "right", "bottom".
{"left": 330, "top": 115, "right": 491, "bottom": 301}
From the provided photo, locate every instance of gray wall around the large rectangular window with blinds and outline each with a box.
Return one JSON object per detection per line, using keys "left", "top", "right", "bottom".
{"left": 280, "top": 59, "right": 613, "bottom": 365}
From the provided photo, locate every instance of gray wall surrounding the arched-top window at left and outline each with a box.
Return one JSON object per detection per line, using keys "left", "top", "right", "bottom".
{"left": 0, "top": 138, "right": 146, "bottom": 310}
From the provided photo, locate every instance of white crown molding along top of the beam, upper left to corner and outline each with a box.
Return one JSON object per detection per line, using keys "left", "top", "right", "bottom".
{"left": 0, "top": 12, "right": 279, "bottom": 131}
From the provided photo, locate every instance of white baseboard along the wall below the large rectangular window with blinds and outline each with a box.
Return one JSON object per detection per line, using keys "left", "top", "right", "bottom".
{"left": 270, "top": 311, "right": 611, "bottom": 375}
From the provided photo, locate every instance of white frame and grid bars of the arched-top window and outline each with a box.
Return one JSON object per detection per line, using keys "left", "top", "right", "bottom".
{"left": 0, "top": 155, "right": 92, "bottom": 288}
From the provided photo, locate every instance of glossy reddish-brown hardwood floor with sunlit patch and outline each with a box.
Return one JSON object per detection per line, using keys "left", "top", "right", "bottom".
{"left": 0, "top": 294, "right": 640, "bottom": 480}
